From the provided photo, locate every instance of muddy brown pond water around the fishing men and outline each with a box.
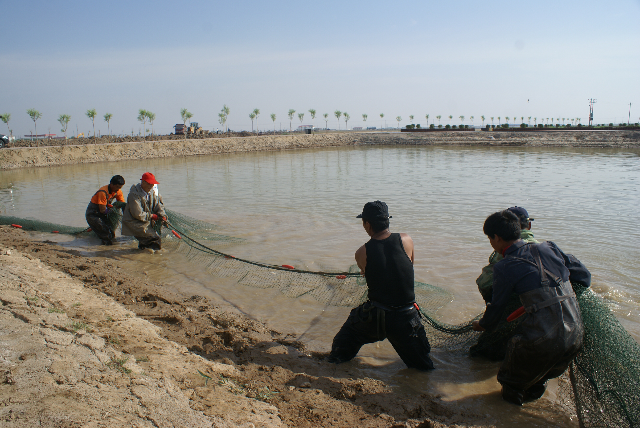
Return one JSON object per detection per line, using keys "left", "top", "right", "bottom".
{"left": 0, "top": 146, "right": 640, "bottom": 426}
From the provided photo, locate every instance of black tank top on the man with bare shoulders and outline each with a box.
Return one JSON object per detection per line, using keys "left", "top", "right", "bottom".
{"left": 364, "top": 233, "right": 416, "bottom": 307}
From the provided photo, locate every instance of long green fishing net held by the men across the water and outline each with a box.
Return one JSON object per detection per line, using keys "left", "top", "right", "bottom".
{"left": 0, "top": 210, "right": 640, "bottom": 428}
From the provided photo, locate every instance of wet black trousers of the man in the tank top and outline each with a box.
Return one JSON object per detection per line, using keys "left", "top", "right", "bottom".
{"left": 328, "top": 302, "right": 433, "bottom": 370}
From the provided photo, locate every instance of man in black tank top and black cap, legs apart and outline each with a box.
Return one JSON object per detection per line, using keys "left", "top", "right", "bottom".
{"left": 328, "top": 201, "right": 433, "bottom": 370}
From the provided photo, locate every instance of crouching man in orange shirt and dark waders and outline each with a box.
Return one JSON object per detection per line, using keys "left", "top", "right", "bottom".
{"left": 84, "top": 175, "right": 124, "bottom": 245}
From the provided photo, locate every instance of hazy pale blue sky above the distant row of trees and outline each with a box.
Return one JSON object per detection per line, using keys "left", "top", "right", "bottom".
{"left": 0, "top": 0, "right": 640, "bottom": 137}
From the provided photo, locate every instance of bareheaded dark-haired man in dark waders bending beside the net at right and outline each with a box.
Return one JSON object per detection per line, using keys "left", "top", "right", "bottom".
{"left": 473, "top": 210, "right": 591, "bottom": 405}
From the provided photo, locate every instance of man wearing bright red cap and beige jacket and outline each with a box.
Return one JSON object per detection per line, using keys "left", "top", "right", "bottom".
{"left": 122, "top": 172, "right": 167, "bottom": 250}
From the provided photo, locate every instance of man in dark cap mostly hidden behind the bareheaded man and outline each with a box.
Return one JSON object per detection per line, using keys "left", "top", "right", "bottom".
{"left": 469, "top": 206, "right": 538, "bottom": 361}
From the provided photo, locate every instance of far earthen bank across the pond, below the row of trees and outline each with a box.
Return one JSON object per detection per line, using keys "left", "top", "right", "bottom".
{"left": 0, "top": 131, "right": 640, "bottom": 169}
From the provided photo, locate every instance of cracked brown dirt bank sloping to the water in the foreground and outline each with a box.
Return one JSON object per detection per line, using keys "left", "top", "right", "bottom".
{"left": 0, "top": 226, "right": 490, "bottom": 428}
